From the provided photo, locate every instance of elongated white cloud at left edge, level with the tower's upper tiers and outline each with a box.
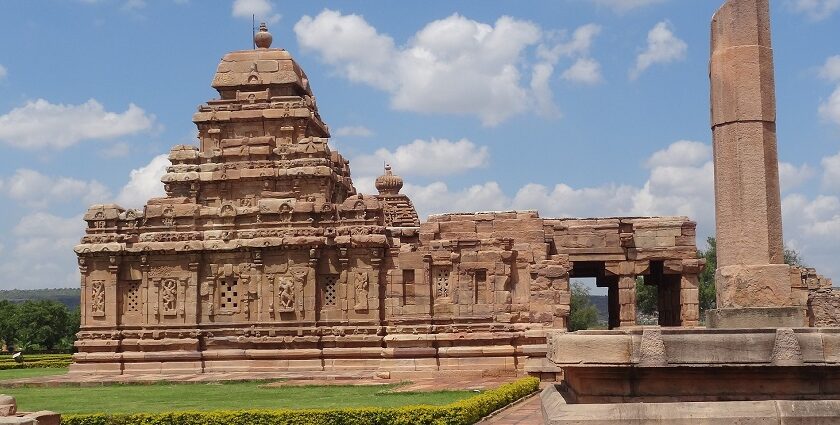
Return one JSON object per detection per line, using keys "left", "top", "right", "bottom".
{"left": 0, "top": 99, "right": 154, "bottom": 149}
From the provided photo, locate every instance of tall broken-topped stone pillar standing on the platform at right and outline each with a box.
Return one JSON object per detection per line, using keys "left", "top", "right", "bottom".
{"left": 710, "top": 0, "right": 804, "bottom": 327}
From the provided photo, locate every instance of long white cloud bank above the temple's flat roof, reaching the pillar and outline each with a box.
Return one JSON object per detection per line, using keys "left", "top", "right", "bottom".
{"left": 390, "top": 141, "right": 714, "bottom": 235}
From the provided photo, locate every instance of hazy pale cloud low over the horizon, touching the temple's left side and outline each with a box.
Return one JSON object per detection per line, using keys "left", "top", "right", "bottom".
{"left": 0, "top": 212, "right": 85, "bottom": 289}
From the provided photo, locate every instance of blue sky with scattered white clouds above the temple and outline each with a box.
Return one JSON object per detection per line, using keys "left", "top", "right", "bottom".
{"left": 0, "top": 0, "right": 840, "bottom": 289}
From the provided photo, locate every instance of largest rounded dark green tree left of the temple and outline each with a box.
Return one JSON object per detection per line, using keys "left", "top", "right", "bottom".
{"left": 14, "top": 301, "right": 70, "bottom": 350}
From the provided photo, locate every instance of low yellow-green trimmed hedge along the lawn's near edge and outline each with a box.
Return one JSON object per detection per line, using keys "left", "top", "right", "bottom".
{"left": 61, "top": 378, "right": 540, "bottom": 425}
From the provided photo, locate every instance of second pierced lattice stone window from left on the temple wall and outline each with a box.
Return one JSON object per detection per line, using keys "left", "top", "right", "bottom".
{"left": 201, "top": 263, "right": 256, "bottom": 316}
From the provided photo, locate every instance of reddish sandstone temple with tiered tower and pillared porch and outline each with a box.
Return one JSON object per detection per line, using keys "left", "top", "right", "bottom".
{"left": 72, "top": 25, "right": 703, "bottom": 373}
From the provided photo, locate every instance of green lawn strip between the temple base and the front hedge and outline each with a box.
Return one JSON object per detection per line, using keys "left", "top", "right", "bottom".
{"left": 0, "top": 380, "right": 474, "bottom": 413}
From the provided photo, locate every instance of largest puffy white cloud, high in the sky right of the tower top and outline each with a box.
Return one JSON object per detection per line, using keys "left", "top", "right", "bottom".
{"left": 294, "top": 10, "right": 600, "bottom": 126}
